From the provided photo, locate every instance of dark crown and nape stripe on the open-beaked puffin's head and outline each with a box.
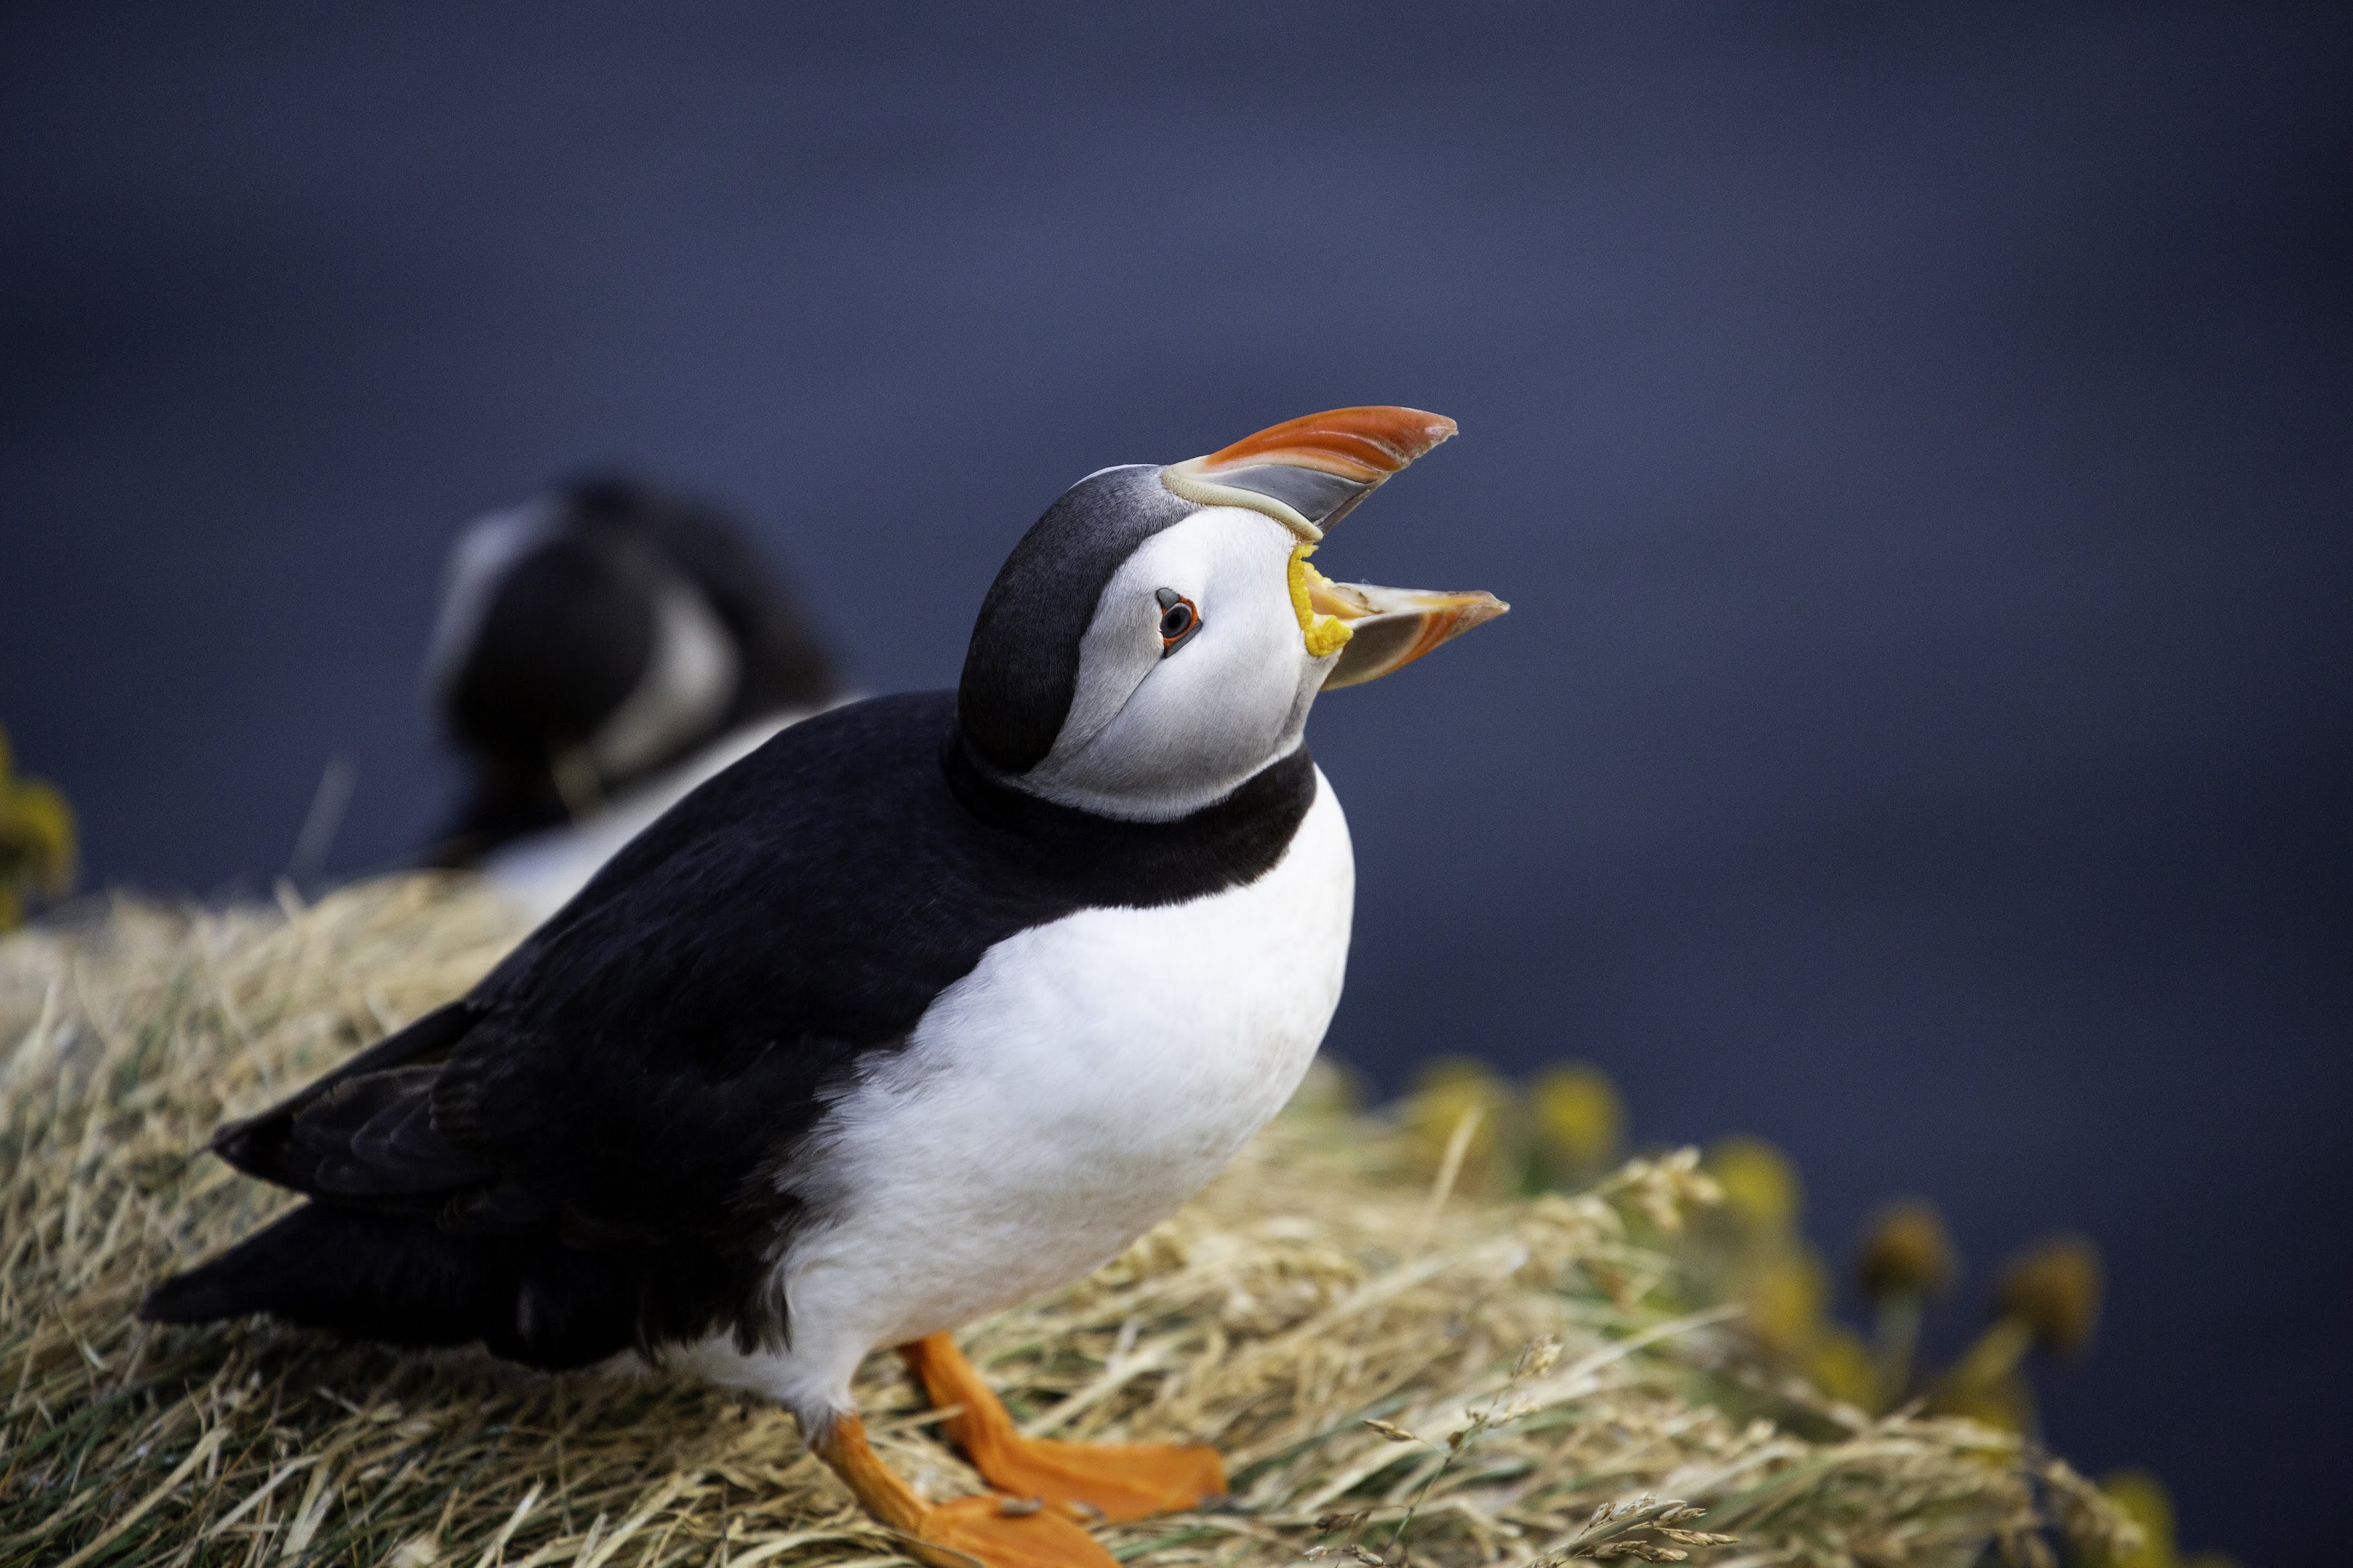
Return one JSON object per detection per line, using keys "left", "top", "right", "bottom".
{"left": 958, "top": 464, "right": 1200, "bottom": 774}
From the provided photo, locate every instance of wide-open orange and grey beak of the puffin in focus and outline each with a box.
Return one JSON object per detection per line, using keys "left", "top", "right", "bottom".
{"left": 1160, "top": 407, "right": 1511, "bottom": 692}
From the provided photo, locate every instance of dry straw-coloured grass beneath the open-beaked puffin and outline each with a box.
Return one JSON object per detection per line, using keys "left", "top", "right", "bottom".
{"left": 0, "top": 878, "right": 2116, "bottom": 1568}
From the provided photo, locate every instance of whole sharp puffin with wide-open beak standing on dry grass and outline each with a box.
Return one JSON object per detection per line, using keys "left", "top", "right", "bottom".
{"left": 139, "top": 407, "right": 1506, "bottom": 1568}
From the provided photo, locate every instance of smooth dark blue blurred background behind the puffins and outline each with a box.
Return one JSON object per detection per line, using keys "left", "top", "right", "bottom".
{"left": 0, "top": 5, "right": 2353, "bottom": 1561}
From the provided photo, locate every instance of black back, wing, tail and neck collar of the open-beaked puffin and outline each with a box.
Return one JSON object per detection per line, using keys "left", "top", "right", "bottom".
{"left": 141, "top": 692, "right": 1315, "bottom": 1365}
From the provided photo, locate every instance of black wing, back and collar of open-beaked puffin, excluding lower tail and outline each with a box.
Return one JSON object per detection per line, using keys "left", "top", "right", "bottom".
{"left": 216, "top": 692, "right": 1315, "bottom": 1327}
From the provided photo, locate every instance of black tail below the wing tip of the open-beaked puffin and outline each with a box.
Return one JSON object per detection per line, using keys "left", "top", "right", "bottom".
{"left": 139, "top": 1203, "right": 642, "bottom": 1371}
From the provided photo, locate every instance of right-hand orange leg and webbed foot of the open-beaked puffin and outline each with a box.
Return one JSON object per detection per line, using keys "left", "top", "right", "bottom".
{"left": 899, "top": 1335, "right": 1226, "bottom": 1521}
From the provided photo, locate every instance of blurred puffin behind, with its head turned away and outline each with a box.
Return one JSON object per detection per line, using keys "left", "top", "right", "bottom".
{"left": 423, "top": 476, "right": 842, "bottom": 921}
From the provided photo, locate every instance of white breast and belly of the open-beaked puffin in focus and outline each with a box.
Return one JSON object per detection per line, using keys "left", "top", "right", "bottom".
{"left": 692, "top": 772, "right": 1355, "bottom": 1408}
